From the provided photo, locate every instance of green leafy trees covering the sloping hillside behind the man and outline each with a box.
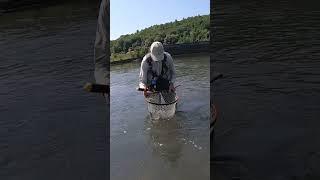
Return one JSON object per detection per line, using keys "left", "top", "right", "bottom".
{"left": 110, "top": 15, "right": 210, "bottom": 60}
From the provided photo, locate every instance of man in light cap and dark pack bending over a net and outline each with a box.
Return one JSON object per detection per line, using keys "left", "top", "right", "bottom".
{"left": 139, "top": 42, "right": 176, "bottom": 102}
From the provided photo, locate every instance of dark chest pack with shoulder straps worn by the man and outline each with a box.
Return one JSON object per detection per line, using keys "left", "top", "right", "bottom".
{"left": 147, "top": 54, "right": 170, "bottom": 91}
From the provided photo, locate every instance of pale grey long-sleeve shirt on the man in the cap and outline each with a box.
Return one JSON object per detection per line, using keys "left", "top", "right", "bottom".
{"left": 139, "top": 52, "right": 176, "bottom": 88}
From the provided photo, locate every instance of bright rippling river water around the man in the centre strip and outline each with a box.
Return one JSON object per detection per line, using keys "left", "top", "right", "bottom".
{"left": 110, "top": 54, "right": 210, "bottom": 180}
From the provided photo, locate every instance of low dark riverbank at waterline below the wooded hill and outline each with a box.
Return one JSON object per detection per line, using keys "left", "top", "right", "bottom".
{"left": 110, "top": 41, "right": 210, "bottom": 65}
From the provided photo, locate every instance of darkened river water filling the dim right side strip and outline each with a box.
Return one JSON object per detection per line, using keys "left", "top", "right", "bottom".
{"left": 212, "top": 0, "right": 320, "bottom": 179}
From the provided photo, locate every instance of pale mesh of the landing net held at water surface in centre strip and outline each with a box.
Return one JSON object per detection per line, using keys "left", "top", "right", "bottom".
{"left": 146, "top": 92, "right": 178, "bottom": 119}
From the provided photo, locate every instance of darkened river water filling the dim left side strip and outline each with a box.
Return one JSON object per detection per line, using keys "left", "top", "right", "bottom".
{"left": 0, "top": 3, "right": 109, "bottom": 180}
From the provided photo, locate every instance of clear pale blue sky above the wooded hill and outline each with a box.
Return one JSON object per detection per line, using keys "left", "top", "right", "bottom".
{"left": 110, "top": 0, "right": 210, "bottom": 40}
